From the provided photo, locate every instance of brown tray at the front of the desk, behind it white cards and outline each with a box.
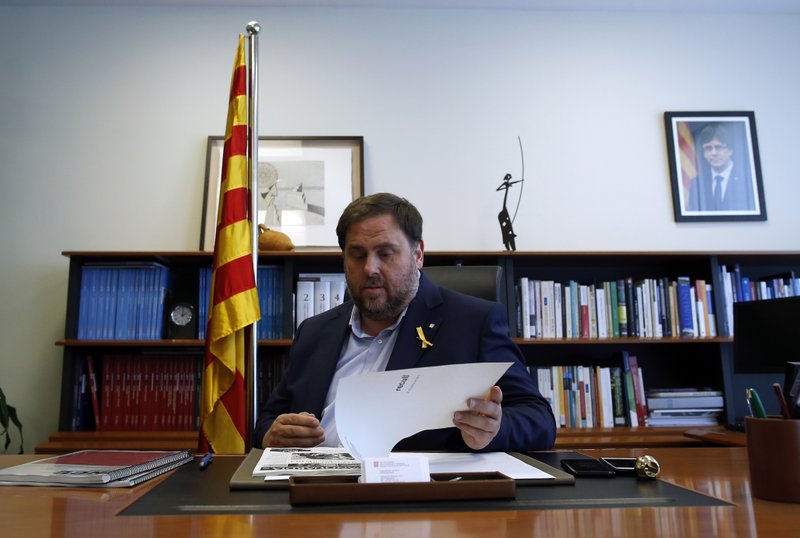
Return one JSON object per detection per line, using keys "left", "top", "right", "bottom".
{"left": 289, "top": 472, "right": 516, "bottom": 506}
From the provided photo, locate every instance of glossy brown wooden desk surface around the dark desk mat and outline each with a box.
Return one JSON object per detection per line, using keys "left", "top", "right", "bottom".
{"left": 0, "top": 447, "right": 800, "bottom": 538}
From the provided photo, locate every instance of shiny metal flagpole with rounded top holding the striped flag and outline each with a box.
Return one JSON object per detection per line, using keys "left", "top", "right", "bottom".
{"left": 245, "top": 21, "right": 263, "bottom": 444}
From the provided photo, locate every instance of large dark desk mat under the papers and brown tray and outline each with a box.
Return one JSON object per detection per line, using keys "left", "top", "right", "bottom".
{"left": 120, "top": 451, "right": 730, "bottom": 516}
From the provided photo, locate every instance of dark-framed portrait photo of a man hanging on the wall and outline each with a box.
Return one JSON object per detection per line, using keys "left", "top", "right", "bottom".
{"left": 664, "top": 112, "right": 767, "bottom": 222}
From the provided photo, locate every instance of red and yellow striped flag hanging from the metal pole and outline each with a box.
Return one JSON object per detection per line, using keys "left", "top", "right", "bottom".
{"left": 200, "top": 36, "right": 261, "bottom": 454}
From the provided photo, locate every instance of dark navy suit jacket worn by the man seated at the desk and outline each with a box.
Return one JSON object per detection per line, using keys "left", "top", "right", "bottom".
{"left": 254, "top": 273, "right": 556, "bottom": 451}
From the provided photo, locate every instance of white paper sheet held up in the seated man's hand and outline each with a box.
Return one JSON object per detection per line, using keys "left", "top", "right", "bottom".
{"left": 336, "top": 362, "right": 512, "bottom": 461}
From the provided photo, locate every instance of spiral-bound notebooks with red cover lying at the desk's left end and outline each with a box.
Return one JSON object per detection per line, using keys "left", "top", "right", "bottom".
{"left": 0, "top": 450, "right": 192, "bottom": 487}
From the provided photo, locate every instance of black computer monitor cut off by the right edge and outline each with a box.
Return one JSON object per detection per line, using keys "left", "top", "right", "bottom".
{"left": 733, "top": 297, "right": 800, "bottom": 375}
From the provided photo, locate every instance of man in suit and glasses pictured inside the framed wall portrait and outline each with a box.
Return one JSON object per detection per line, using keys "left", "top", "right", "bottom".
{"left": 687, "top": 123, "right": 755, "bottom": 211}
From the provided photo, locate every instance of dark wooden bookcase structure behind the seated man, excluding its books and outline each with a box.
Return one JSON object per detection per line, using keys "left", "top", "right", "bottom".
{"left": 43, "top": 249, "right": 800, "bottom": 452}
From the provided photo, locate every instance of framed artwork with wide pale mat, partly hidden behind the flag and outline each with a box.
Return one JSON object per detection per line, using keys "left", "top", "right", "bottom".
{"left": 200, "top": 136, "right": 364, "bottom": 251}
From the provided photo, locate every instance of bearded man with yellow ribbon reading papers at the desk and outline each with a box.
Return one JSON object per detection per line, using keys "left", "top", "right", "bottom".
{"left": 254, "top": 194, "right": 556, "bottom": 451}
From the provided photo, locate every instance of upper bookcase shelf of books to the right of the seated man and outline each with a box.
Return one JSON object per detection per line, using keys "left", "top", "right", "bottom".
{"left": 510, "top": 253, "right": 718, "bottom": 340}
